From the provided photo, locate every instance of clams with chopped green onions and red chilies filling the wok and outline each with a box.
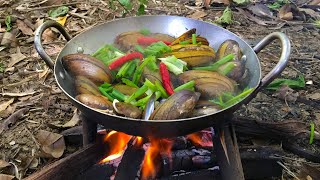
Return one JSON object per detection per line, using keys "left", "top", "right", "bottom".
{"left": 62, "top": 29, "right": 253, "bottom": 120}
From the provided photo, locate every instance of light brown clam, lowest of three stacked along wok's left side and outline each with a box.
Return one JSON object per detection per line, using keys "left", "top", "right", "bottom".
{"left": 76, "top": 94, "right": 113, "bottom": 110}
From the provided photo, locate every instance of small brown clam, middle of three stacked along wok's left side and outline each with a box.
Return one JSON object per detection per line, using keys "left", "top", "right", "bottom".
{"left": 74, "top": 76, "right": 101, "bottom": 96}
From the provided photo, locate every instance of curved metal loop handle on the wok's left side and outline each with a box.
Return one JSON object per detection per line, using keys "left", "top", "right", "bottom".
{"left": 34, "top": 21, "right": 71, "bottom": 69}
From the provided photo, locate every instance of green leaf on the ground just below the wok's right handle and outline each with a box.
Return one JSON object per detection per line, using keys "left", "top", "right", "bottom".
{"left": 266, "top": 75, "right": 306, "bottom": 90}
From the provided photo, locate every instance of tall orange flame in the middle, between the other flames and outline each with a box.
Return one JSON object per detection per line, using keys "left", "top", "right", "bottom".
{"left": 141, "top": 139, "right": 172, "bottom": 179}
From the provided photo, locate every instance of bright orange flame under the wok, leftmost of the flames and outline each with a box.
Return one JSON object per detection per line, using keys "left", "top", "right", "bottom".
{"left": 99, "top": 131, "right": 131, "bottom": 164}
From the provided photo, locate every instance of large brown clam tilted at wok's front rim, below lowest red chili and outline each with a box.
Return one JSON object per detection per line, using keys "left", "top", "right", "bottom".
{"left": 150, "top": 90, "right": 200, "bottom": 120}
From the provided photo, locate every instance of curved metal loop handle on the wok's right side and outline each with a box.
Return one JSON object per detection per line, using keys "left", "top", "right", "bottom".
{"left": 244, "top": 32, "right": 291, "bottom": 104}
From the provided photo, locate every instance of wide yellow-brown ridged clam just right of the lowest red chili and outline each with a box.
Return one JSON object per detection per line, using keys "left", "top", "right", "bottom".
{"left": 179, "top": 70, "right": 235, "bottom": 98}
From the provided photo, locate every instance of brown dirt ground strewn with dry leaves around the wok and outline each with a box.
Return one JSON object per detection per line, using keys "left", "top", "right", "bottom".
{"left": 0, "top": 0, "right": 320, "bottom": 178}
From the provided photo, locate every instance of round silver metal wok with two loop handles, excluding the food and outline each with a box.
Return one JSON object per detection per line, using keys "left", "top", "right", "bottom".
{"left": 34, "top": 16, "right": 291, "bottom": 138}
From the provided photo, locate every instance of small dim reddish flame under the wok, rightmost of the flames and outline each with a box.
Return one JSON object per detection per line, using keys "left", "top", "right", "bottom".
{"left": 187, "top": 131, "right": 213, "bottom": 147}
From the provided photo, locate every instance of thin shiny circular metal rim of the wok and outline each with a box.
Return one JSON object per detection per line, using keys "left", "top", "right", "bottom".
{"left": 53, "top": 15, "right": 262, "bottom": 123}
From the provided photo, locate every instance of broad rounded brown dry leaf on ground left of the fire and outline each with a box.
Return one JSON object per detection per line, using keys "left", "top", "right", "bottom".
{"left": 36, "top": 130, "right": 66, "bottom": 158}
